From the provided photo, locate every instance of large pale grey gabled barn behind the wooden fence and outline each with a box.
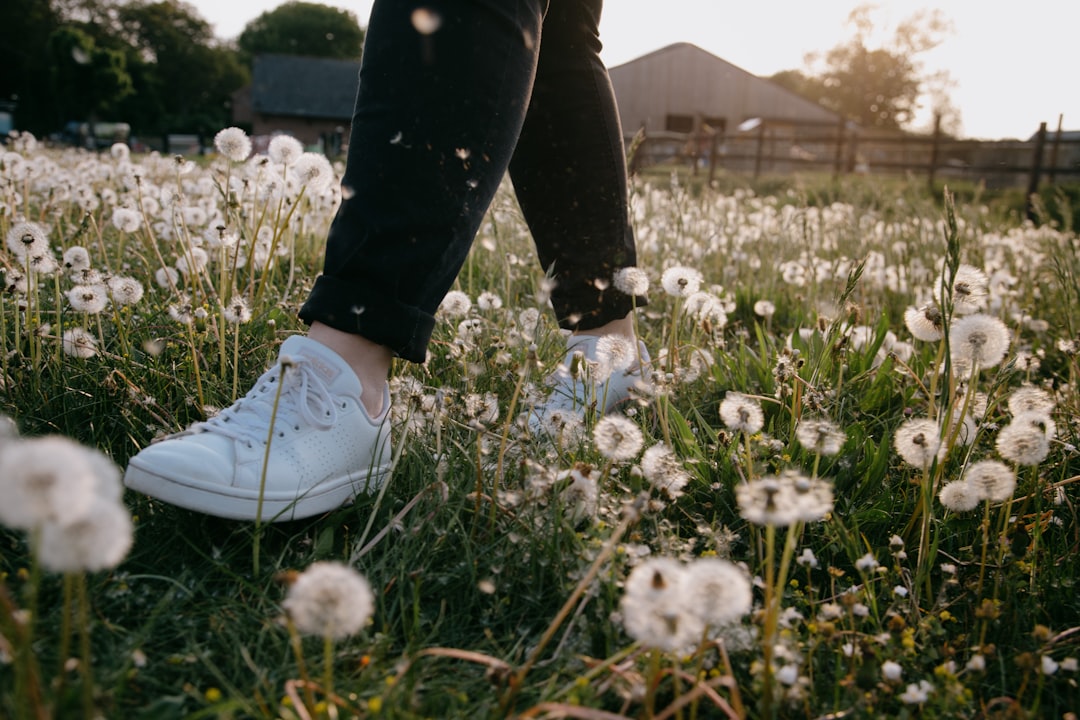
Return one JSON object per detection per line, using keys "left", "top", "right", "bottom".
{"left": 609, "top": 42, "right": 842, "bottom": 169}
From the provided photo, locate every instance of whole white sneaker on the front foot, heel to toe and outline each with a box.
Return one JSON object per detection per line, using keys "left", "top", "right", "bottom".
{"left": 124, "top": 335, "right": 391, "bottom": 520}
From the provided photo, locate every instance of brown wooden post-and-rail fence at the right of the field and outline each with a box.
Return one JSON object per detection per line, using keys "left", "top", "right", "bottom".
{"left": 627, "top": 121, "right": 1080, "bottom": 197}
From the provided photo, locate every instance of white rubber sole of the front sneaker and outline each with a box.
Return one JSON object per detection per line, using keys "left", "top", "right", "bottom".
{"left": 124, "top": 460, "right": 390, "bottom": 522}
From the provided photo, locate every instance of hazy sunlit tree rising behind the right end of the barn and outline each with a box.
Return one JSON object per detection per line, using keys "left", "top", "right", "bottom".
{"left": 773, "top": 5, "right": 950, "bottom": 130}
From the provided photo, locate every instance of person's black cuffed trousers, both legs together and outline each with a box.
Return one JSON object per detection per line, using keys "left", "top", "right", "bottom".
{"left": 300, "top": 0, "right": 644, "bottom": 362}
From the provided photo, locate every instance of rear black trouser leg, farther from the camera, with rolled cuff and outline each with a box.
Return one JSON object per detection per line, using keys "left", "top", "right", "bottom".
{"left": 510, "top": 0, "right": 645, "bottom": 337}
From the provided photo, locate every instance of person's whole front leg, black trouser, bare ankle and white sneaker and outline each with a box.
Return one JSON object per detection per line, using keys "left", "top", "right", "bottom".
{"left": 124, "top": 0, "right": 546, "bottom": 519}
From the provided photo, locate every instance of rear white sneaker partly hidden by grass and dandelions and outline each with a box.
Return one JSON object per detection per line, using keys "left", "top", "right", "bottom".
{"left": 528, "top": 335, "right": 650, "bottom": 433}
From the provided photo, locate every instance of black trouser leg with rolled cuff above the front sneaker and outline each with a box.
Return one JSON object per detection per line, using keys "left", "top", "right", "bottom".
{"left": 300, "top": 0, "right": 548, "bottom": 377}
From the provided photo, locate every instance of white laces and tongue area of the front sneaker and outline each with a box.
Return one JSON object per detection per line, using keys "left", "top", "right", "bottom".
{"left": 193, "top": 356, "right": 338, "bottom": 447}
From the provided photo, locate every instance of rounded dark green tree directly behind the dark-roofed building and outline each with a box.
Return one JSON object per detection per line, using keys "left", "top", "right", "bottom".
{"left": 237, "top": 1, "right": 364, "bottom": 62}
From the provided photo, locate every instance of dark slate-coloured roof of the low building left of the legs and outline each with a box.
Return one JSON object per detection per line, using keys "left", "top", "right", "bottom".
{"left": 252, "top": 55, "right": 360, "bottom": 120}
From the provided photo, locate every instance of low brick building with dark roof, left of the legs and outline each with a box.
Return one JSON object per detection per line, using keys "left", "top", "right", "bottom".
{"left": 232, "top": 55, "right": 360, "bottom": 151}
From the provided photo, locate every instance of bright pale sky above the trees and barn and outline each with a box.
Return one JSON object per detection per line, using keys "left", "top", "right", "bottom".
{"left": 188, "top": 0, "right": 1080, "bottom": 139}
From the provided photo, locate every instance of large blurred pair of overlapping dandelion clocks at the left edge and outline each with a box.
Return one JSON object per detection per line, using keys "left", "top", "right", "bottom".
{"left": 0, "top": 418, "right": 133, "bottom": 572}
